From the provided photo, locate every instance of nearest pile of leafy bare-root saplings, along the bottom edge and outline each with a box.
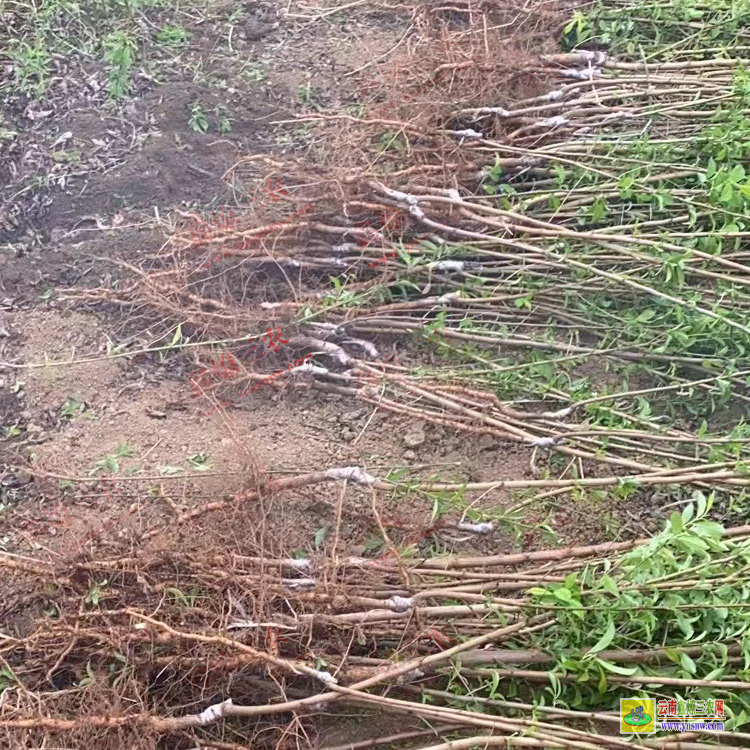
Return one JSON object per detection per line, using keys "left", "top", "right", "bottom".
{"left": 0, "top": 496, "right": 750, "bottom": 750}
